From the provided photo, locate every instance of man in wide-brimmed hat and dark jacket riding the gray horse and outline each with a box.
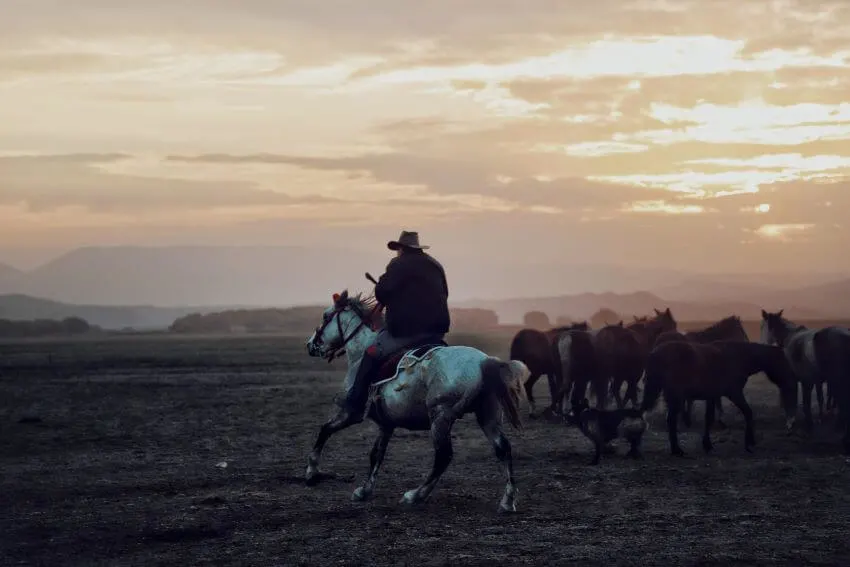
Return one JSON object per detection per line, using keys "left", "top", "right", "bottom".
{"left": 343, "top": 231, "right": 451, "bottom": 423}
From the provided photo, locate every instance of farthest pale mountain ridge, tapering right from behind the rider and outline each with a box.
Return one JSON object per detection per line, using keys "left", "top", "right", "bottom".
{"left": 0, "top": 246, "right": 687, "bottom": 307}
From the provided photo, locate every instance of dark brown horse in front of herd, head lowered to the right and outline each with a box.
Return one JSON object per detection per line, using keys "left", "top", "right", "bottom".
{"left": 641, "top": 341, "right": 797, "bottom": 457}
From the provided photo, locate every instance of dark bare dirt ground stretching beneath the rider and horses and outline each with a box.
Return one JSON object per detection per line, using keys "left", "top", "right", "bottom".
{"left": 0, "top": 337, "right": 850, "bottom": 567}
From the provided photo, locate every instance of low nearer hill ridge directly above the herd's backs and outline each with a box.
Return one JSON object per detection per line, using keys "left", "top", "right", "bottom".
{"left": 454, "top": 292, "right": 826, "bottom": 324}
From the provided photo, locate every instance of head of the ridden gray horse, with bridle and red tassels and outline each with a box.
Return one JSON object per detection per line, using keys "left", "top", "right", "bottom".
{"left": 307, "top": 290, "right": 376, "bottom": 360}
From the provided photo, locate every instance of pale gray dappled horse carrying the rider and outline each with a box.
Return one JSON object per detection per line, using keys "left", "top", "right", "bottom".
{"left": 306, "top": 290, "right": 528, "bottom": 512}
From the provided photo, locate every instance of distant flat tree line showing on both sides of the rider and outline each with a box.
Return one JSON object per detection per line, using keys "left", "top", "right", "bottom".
{"left": 169, "top": 306, "right": 499, "bottom": 334}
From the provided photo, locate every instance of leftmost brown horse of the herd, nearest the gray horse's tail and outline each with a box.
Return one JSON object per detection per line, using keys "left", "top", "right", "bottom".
{"left": 510, "top": 321, "right": 590, "bottom": 418}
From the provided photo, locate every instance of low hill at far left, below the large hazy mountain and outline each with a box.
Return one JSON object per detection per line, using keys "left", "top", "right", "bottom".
{"left": 0, "top": 295, "right": 225, "bottom": 330}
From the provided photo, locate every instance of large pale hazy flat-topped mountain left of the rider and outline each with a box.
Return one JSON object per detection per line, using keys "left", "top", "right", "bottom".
{"left": 0, "top": 246, "right": 389, "bottom": 308}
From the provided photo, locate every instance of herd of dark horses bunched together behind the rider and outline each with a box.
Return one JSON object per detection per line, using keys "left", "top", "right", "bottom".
{"left": 510, "top": 308, "right": 850, "bottom": 456}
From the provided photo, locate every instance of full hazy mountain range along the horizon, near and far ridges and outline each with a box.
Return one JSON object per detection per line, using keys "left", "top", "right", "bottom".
{"left": 0, "top": 246, "right": 850, "bottom": 329}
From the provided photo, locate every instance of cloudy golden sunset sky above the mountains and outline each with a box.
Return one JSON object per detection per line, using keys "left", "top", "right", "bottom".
{"left": 0, "top": 0, "right": 850, "bottom": 271}
